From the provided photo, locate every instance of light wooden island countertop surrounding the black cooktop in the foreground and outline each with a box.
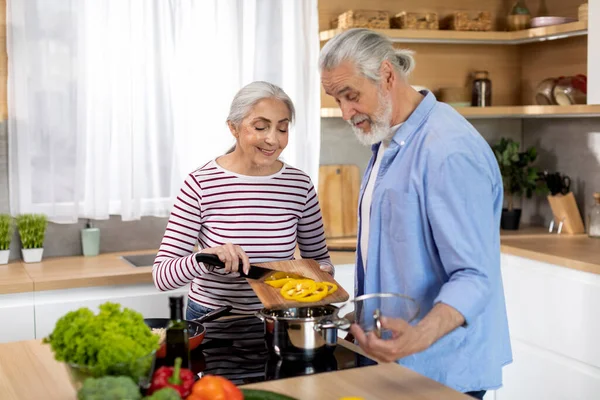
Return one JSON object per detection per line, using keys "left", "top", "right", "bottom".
{"left": 0, "top": 340, "right": 470, "bottom": 400}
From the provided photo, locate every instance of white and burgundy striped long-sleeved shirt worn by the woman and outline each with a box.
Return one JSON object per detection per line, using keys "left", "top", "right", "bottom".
{"left": 152, "top": 160, "right": 332, "bottom": 314}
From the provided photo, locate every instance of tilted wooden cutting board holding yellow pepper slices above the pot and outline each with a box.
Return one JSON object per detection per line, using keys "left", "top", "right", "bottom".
{"left": 247, "top": 259, "right": 350, "bottom": 309}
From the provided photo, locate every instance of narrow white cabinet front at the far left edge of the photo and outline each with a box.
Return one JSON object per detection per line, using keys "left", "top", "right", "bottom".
{"left": 0, "top": 292, "right": 35, "bottom": 343}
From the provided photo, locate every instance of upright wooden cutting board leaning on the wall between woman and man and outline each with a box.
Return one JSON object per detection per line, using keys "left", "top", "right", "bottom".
{"left": 319, "top": 164, "right": 360, "bottom": 238}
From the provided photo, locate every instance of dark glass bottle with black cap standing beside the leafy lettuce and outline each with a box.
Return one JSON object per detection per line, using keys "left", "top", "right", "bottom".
{"left": 165, "top": 296, "right": 190, "bottom": 368}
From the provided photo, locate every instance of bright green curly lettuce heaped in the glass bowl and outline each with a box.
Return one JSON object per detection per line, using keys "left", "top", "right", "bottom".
{"left": 44, "top": 302, "right": 159, "bottom": 379}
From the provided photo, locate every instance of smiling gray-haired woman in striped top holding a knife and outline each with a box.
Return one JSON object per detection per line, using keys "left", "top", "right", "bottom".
{"left": 152, "top": 82, "right": 333, "bottom": 319}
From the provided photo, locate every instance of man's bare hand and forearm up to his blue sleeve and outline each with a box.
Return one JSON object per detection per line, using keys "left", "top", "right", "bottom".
{"left": 350, "top": 303, "right": 465, "bottom": 362}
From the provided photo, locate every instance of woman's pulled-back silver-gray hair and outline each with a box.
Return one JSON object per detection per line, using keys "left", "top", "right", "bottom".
{"left": 227, "top": 81, "right": 296, "bottom": 127}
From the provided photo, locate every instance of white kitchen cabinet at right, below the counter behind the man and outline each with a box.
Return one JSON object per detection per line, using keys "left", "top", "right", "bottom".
{"left": 495, "top": 254, "right": 600, "bottom": 400}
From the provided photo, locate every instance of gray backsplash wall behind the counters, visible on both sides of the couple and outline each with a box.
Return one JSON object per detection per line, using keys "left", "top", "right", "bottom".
{"left": 0, "top": 118, "right": 600, "bottom": 259}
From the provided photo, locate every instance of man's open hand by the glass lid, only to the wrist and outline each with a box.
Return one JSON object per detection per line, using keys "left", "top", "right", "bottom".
{"left": 350, "top": 317, "right": 431, "bottom": 362}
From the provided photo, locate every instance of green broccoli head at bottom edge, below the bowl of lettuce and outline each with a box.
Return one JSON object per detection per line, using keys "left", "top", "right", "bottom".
{"left": 77, "top": 376, "right": 142, "bottom": 400}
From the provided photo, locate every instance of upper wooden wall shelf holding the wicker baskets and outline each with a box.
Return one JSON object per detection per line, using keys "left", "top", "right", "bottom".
{"left": 319, "top": 21, "right": 587, "bottom": 45}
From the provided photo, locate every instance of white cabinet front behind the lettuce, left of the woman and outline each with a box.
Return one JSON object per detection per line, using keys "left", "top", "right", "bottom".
{"left": 32, "top": 284, "right": 188, "bottom": 339}
